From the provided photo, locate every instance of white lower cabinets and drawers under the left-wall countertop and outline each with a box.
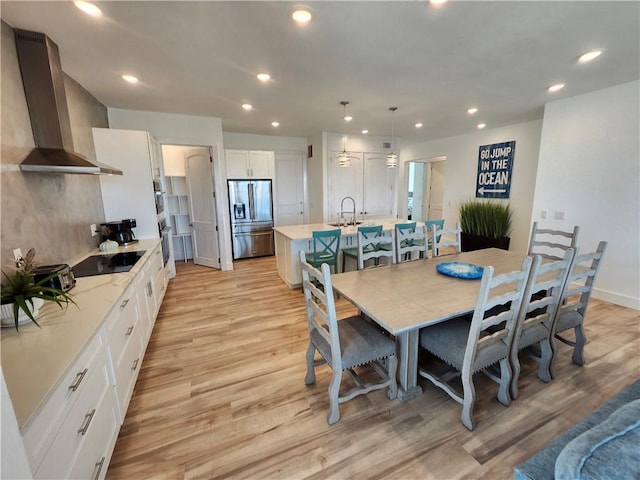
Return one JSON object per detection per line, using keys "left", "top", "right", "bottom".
{"left": 22, "top": 245, "right": 168, "bottom": 479}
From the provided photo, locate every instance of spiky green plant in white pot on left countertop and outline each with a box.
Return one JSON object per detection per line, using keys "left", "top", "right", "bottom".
{"left": 0, "top": 248, "right": 76, "bottom": 330}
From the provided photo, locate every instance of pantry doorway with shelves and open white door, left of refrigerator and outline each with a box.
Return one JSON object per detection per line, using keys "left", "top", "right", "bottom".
{"left": 162, "top": 145, "right": 220, "bottom": 269}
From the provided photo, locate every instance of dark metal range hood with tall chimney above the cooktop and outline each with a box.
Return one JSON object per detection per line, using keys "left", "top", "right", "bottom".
{"left": 14, "top": 29, "right": 122, "bottom": 175}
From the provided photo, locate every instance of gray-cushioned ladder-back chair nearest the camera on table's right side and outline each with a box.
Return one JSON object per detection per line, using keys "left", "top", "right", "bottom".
{"left": 418, "top": 257, "right": 532, "bottom": 430}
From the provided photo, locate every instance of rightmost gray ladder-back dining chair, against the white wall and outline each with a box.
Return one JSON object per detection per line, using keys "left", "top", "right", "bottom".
{"left": 550, "top": 242, "right": 607, "bottom": 378}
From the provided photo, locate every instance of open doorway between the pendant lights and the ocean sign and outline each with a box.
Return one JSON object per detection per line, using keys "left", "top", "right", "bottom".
{"left": 407, "top": 157, "right": 446, "bottom": 222}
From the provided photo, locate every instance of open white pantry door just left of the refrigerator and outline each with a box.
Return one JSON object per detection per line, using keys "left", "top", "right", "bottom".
{"left": 185, "top": 147, "right": 220, "bottom": 268}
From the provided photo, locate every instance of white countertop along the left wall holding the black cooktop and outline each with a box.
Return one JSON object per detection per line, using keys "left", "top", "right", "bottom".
{"left": 0, "top": 239, "right": 160, "bottom": 428}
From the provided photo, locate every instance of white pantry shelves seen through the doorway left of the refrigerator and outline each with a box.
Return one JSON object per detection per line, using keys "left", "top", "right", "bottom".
{"left": 166, "top": 176, "right": 193, "bottom": 262}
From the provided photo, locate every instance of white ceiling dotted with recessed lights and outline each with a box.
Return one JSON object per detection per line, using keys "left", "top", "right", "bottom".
{"left": 0, "top": 1, "right": 640, "bottom": 142}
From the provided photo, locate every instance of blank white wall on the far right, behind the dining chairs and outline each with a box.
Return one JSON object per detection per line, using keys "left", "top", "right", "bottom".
{"left": 532, "top": 81, "right": 640, "bottom": 309}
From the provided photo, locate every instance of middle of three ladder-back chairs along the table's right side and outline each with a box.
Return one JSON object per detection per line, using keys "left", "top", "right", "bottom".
{"left": 510, "top": 248, "right": 575, "bottom": 400}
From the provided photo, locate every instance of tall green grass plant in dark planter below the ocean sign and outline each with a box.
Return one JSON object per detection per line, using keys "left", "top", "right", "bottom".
{"left": 459, "top": 199, "right": 513, "bottom": 252}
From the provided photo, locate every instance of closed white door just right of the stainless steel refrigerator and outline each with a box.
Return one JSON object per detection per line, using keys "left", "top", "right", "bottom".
{"left": 274, "top": 153, "right": 304, "bottom": 227}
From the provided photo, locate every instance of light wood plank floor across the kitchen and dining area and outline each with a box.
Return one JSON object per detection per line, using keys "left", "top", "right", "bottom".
{"left": 107, "top": 257, "right": 640, "bottom": 479}
